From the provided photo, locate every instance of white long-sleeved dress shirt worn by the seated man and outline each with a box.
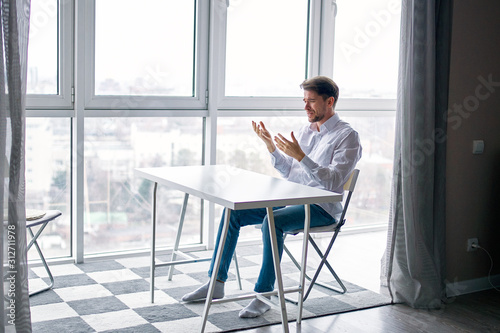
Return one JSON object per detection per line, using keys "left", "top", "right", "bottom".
{"left": 271, "top": 113, "right": 362, "bottom": 219}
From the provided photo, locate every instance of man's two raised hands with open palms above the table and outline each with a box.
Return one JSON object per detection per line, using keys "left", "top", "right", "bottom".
{"left": 252, "top": 121, "right": 306, "bottom": 162}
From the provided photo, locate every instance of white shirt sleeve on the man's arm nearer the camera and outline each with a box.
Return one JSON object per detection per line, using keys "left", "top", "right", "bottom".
{"left": 299, "top": 130, "right": 362, "bottom": 191}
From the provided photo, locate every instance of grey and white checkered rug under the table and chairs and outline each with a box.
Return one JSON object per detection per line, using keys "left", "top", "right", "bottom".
{"left": 29, "top": 246, "right": 390, "bottom": 333}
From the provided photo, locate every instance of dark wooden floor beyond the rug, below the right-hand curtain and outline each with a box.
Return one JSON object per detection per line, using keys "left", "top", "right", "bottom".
{"left": 244, "top": 289, "right": 500, "bottom": 333}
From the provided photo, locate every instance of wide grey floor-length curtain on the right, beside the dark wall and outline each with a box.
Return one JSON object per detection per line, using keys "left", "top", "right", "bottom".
{"left": 382, "top": 0, "right": 452, "bottom": 309}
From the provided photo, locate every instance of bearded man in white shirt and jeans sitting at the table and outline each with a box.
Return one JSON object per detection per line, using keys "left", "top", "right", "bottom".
{"left": 182, "top": 76, "right": 361, "bottom": 318}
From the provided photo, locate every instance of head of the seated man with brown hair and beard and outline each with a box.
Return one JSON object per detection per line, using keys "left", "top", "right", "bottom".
{"left": 300, "top": 76, "right": 339, "bottom": 126}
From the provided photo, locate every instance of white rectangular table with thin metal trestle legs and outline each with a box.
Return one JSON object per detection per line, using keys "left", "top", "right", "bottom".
{"left": 135, "top": 165, "right": 342, "bottom": 332}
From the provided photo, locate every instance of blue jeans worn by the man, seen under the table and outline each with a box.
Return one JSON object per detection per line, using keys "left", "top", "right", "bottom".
{"left": 208, "top": 205, "right": 335, "bottom": 293}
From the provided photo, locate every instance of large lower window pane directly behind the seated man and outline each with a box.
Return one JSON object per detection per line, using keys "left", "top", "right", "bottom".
{"left": 216, "top": 113, "right": 395, "bottom": 233}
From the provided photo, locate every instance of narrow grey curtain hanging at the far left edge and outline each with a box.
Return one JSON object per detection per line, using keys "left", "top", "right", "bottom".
{"left": 0, "top": 0, "right": 31, "bottom": 332}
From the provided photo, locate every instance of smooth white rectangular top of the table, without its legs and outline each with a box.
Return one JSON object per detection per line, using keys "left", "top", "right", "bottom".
{"left": 134, "top": 165, "right": 342, "bottom": 210}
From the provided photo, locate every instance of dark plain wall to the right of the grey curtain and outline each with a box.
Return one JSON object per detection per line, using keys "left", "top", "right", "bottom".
{"left": 446, "top": 0, "right": 500, "bottom": 282}
